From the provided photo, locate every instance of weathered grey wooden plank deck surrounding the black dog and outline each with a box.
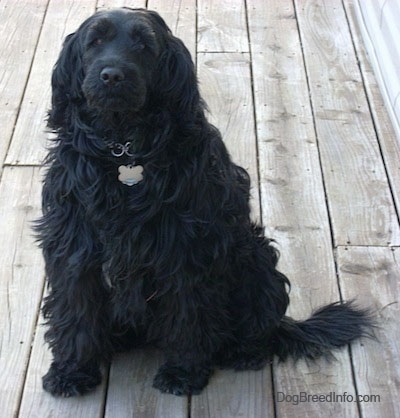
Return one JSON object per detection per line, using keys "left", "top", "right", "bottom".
{"left": 0, "top": 0, "right": 400, "bottom": 418}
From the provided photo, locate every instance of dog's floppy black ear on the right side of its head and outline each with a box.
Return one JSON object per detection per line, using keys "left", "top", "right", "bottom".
{"left": 155, "top": 29, "right": 200, "bottom": 120}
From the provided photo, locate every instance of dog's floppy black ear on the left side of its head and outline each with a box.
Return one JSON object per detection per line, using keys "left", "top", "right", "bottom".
{"left": 47, "top": 32, "right": 83, "bottom": 130}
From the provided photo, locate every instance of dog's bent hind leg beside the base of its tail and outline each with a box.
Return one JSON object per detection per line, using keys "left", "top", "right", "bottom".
{"left": 217, "top": 236, "right": 289, "bottom": 370}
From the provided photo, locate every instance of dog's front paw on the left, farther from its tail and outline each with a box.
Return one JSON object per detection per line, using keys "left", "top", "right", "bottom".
{"left": 43, "top": 363, "right": 101, "bottom": 398}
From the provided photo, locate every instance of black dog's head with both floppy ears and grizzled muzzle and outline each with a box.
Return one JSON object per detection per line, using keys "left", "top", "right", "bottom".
{"left": 49, "top": 8, "right": 199, "bottom": 129}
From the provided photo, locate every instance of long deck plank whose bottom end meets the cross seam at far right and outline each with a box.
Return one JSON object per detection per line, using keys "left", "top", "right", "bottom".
{"left": 295, "top": 0, "right": 400, "bottom": 245}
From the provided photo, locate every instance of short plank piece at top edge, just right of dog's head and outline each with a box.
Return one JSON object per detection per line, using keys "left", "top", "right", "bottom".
{"left": 197, "top": 0, "right": 249, "bottom": 52}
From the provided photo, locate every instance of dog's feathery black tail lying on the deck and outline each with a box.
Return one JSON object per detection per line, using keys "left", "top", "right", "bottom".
{"left": 272, "top": 302, "right": 376, "bottom": 361}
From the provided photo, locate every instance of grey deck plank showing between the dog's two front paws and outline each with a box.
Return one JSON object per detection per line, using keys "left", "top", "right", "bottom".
{"left": 105, "top": 349, "right": 188, "bottom": 418}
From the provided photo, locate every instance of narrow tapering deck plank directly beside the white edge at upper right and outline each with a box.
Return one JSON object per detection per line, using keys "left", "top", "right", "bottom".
{"left": 344, "top": 0, "right": 400, "bottom": 225}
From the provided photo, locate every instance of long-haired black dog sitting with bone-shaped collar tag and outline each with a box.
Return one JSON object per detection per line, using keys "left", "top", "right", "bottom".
{"left": 37, "top": 9, "right": 371, "bottom": 396}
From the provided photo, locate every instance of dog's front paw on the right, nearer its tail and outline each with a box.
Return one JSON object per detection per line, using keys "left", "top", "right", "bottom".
{"left": 153, "top": 363, "right": 211, "bottom": 395}
